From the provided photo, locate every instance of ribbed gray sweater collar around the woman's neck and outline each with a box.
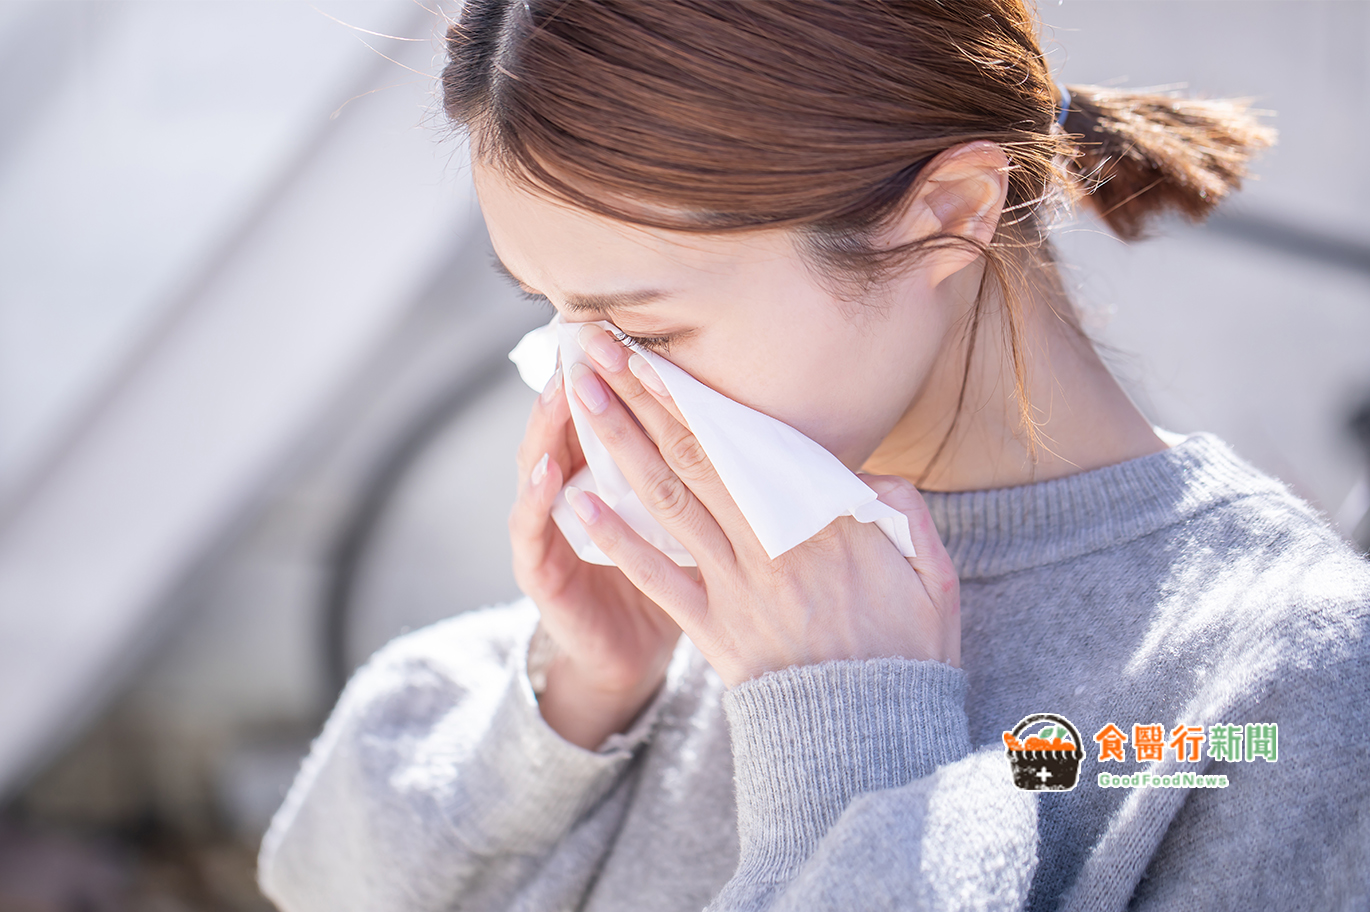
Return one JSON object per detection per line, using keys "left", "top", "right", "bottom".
{"left": 922, "top": 431, "right": 1288, "bottom": 579}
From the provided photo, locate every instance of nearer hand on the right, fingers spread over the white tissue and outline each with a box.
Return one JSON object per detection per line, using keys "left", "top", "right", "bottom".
{"left": 567, "top": 325, "right": 960, "bottom": 687}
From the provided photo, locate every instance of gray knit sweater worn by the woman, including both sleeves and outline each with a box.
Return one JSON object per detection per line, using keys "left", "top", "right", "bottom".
{"left": 259, "top": 433, "right": 1370, "bottom": 912}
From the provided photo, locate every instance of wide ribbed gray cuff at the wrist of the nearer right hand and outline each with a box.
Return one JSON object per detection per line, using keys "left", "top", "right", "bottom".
{"left": 723, "top": 657, "right": 970, "bottom": 881}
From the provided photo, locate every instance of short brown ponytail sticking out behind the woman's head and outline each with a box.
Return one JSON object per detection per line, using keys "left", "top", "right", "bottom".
{"left": 1064, "top": 85, "right": 1275, "bottom": 241}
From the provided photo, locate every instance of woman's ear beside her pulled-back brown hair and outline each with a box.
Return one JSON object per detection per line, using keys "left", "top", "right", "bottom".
{"left": 885, "top": 141, "right": 1010, "bottom": 285}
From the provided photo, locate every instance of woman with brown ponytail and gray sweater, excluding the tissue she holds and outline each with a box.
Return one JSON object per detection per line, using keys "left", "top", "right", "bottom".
{"left": 260, "top": 0, "right": 1370, "bottom": 912}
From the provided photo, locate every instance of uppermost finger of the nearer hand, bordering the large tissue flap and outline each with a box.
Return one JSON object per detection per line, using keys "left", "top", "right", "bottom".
{"left": 569, "top": 325, "right": 764, "bottom": 553}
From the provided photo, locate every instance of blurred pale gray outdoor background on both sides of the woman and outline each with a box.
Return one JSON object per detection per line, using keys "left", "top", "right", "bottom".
{"left": 0, "top": 0, "right": 1370, "bottom": 912}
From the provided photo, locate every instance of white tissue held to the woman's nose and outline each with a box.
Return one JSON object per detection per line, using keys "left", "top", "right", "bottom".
{"left": 510, "top": 314, "right": 915, "bottom": 567}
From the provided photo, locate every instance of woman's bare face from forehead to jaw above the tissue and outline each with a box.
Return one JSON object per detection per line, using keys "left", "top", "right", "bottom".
{"left": 474, "top": 164, "right": 949, "bottom": 471}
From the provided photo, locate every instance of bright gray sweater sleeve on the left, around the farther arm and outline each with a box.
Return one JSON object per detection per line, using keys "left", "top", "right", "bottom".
{"left": 258, "top": 600, "right": 670, "bottom": 912}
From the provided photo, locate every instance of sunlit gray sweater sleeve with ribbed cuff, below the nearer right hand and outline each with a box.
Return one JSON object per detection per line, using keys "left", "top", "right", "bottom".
{"left": 706, "top": 659, "right": 1037, "bottom": 912}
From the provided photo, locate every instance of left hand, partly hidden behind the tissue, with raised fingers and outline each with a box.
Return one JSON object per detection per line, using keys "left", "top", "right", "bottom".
{"left": 508, "top": 350, "right": 680, "bottom": 712}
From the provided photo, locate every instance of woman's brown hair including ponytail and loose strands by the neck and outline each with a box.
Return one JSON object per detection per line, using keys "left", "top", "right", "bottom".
{"left": 443, "top": 0, "right": 1274, "bottom": 477}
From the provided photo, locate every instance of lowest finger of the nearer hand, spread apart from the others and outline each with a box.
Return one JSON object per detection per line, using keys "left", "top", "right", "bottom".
{"left": 566, "top": 485, "right": 708, "bottom": 632}
